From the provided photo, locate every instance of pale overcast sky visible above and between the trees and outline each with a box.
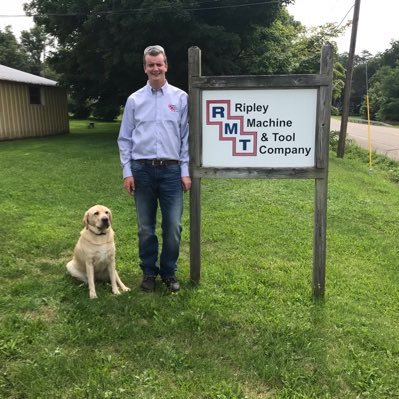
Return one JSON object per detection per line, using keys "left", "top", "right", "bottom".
{"left": 0, "top": 0, "right": 399, "bottom": 55}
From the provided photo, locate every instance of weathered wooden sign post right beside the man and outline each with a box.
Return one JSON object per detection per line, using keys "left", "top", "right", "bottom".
{"left": 188, "top": 47, "right": 201, "bottom": 283}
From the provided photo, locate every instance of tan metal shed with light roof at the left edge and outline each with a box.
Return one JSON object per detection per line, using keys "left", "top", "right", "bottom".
{"left": 0, "top": 65, "right": 69, "bottom": 140}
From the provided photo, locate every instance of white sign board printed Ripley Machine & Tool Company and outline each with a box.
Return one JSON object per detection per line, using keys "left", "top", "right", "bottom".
{"left": 202, "top": 89, "right": 317, "bottom": 168}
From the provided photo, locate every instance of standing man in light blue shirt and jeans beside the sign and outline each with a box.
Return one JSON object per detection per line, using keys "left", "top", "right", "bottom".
{"left": 118, "top": 45, "right": 191, "bottom": 292}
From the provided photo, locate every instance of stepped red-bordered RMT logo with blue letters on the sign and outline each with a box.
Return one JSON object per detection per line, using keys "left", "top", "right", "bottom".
{"left": 206, "top": 100, "right": 257, "bottom": 156}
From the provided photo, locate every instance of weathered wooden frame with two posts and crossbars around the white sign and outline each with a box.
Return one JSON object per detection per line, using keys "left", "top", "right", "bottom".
{"left": 188, "top": 43, "right": 333, "bottom": 298}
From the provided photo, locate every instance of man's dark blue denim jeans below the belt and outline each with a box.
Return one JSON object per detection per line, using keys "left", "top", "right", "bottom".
{"left": 132, "top": 161, "right": 183, "bottom": 278}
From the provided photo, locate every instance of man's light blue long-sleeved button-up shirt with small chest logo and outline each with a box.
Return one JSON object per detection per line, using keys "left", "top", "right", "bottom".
{"left": 118, "top": 82, "right": 189, "bottom": 178}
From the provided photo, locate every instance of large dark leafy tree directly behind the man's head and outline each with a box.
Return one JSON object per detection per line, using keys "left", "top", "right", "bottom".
{"left": 25, "top": 0, "right": 292, "bottom": 118}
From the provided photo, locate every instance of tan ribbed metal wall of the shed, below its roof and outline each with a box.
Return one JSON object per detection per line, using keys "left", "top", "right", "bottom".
{"left": 0, "top": 81, "right": 69, "bottom": 140}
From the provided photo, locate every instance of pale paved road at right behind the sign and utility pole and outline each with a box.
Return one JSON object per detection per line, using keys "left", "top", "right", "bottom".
{"left": 330, "top": 119, "right": 399, "bottom": 161}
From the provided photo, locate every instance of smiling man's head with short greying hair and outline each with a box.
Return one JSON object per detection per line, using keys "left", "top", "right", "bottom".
{"left": 143, "top": 45, "right": 168, "bottom": 89}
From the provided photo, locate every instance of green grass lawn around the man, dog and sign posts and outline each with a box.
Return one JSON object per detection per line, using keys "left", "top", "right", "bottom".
{"left": 0, "top": 122, "right": 399, "bottom": 399}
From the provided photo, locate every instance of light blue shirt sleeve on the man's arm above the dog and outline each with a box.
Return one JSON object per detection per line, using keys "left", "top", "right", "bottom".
{"left": 118, "top": 97, "right": 134, "bottom": 178}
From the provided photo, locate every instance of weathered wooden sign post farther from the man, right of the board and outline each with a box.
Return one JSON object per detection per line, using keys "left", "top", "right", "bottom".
{"left": 312, "top": 44, "right": 333, "bottom": 298}
